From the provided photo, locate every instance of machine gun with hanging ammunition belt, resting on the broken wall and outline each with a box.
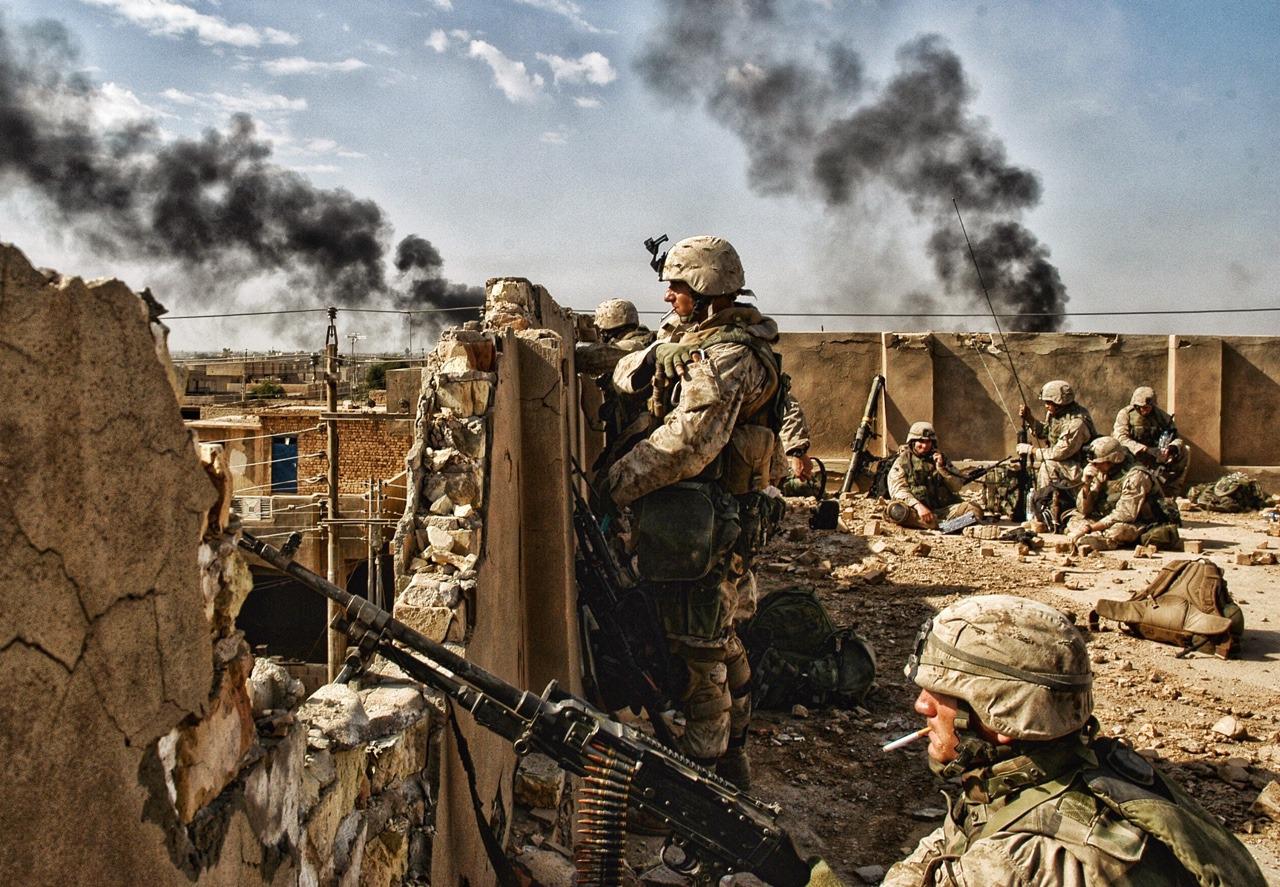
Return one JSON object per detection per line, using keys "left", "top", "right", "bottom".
{"left": 239, "top": 532, "right": 809, "bottom": 887}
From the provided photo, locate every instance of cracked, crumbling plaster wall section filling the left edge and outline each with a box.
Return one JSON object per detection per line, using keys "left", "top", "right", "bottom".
{"left": 0, "top": 244, "right": 438, "bottom": 887}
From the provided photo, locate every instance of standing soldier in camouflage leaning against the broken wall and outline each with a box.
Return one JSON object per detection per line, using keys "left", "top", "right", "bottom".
{"left": 608, "top": 237, "right": 781, "bottom": 787}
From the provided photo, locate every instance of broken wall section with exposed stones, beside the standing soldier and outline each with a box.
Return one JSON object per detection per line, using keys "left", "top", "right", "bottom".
{"left": 394, "top": 278, "right": 582, "bottom": 886}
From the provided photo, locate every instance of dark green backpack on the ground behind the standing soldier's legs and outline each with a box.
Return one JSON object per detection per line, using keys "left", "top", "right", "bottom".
{"left": 739, "top": 589, "right": 876, "bottom": 709}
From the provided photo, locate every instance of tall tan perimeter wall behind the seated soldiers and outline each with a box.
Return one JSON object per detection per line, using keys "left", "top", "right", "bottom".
{"left": 781, "top": 333, "right": 1280, "bottom": 486}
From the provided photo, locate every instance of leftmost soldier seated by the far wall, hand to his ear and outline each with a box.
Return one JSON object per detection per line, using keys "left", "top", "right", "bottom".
{"left": 888, "top": 422, "right": 982, "bottom": 530}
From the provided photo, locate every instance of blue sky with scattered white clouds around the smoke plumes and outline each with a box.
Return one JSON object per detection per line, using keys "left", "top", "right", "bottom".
{"left": 0, "top": 0, "right": 1280, "bottom": 348}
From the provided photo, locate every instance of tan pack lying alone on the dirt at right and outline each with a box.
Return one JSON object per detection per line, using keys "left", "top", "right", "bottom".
{"left": 1094, "top": 558, "right": 1244, "bottom": 659}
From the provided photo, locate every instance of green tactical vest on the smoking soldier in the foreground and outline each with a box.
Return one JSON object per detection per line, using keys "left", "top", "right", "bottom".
{"left": 925, "top": 739, "right": 1266, "bottom": 887}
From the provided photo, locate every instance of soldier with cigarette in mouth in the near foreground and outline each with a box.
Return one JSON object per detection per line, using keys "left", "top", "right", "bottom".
{"left": 865, "top": 595, "right": 1265, "bottom": 887}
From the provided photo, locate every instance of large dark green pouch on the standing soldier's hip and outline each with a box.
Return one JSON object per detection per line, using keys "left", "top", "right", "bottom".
{"left": 632, "top": 480, "right": 742, "bottom": 582}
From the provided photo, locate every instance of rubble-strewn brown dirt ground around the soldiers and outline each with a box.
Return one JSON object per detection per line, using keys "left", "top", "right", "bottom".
{"left": 749, "top": 499, "right": 1280, "bottom": 884}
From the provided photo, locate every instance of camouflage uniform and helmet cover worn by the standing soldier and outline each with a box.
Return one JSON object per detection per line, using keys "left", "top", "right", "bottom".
{"left": 608, "top": 238, "right": 780, "bottom": 787}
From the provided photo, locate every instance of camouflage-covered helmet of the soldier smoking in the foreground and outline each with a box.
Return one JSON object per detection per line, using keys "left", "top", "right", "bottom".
{"left": 904, "top": 594, "right": 1093, "bottom": 741}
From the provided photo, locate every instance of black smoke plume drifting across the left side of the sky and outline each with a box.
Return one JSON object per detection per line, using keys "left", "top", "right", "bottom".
{"left": 0, "top": 20, "right": 481, "bottom": 337}
